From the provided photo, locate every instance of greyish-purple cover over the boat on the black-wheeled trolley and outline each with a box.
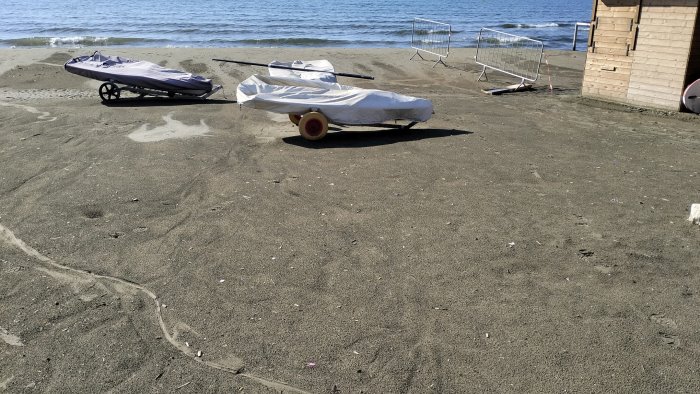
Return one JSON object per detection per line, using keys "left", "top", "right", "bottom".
{"left": 64, "top": 52, "right": 214, "bottom": 95}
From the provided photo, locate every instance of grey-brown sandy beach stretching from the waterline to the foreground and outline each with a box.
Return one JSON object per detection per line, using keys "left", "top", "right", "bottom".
{"left": 0, "top": 48, "right": 700, "bottom": 393}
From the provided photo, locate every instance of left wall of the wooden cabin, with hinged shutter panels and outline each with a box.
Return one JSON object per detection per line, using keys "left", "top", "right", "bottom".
{"left": 581, "top": 0, "right": 638, "bottom": 101}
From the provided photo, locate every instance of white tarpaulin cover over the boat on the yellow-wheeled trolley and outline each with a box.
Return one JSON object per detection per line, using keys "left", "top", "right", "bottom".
{"left": 236, "top": 75, "right": 433, "bottom": 125}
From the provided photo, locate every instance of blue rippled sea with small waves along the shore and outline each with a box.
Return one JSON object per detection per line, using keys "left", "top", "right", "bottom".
{"left": 0, "top": 0, "right": 591, "bottom": 49}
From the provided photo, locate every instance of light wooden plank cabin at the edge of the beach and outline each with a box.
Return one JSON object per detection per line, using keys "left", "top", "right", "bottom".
{"left": 581, "top": 0, "right": 700, "bottom": 111}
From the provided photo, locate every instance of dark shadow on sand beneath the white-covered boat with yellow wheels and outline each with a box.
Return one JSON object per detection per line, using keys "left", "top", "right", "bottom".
{"left": 282, "top": 129, "right": 473, "bottom": 149}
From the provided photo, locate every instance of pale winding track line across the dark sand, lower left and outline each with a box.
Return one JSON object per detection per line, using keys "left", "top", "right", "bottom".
{"left": 0, "top": 224, "right": 310, "bottom": 394}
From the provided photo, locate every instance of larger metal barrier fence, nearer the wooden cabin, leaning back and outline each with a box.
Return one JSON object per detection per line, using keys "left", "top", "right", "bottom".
{"left": 475, "top": 27, "right": 544, "bottom": 85}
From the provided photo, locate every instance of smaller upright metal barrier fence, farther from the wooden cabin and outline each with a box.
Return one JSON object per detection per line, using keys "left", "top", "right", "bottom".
{"left": 411, "top": 18, "right": 452, "bottom": 67}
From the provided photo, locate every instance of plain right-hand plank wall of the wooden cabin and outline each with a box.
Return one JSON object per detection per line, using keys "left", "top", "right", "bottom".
{"left": 627, "top": 0, "right": 698, "bottom": 111}
